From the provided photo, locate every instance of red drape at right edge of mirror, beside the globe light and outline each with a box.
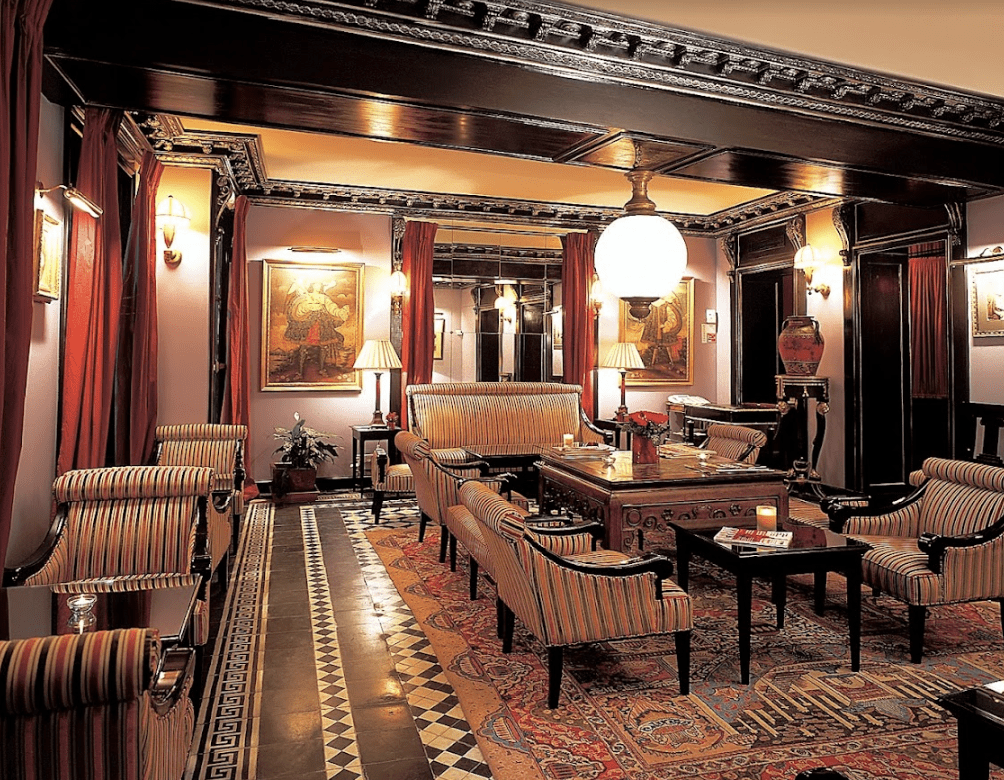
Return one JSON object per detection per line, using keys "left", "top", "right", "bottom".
{"left": 561, "top": 232, "right": 596, "bottom": 417}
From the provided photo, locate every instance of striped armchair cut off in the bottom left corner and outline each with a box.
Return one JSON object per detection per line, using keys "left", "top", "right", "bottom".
{"left": 0, "top": 628, "right": 195, "bottom": 780}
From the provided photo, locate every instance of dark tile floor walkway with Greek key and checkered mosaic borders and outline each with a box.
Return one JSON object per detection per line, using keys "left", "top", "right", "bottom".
{"left": 186, "top": 493, "right": 491, "bottom": 780}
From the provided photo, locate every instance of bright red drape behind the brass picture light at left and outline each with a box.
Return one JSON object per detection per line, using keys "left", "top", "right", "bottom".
{"left": 56, "top": 108, "right": 122, "bottom": 474}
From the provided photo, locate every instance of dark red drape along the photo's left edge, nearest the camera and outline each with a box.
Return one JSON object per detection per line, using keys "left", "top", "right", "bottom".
{"left": 0, "top": 0, "right": 52, "bottom": 564}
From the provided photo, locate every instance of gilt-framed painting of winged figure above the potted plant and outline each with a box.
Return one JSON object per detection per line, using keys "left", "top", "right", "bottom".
{"left": 261, "top": 260, "right": 362, "bottom": 391}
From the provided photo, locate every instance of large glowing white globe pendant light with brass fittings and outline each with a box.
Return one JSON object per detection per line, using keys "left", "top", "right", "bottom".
{"left": 595, "top": 170, "right": 687, "bottom": 319}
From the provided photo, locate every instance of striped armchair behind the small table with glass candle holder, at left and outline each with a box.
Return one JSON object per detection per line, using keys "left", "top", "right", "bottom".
{"left": 4, "top": 466, "right": 214, "bottom": 645}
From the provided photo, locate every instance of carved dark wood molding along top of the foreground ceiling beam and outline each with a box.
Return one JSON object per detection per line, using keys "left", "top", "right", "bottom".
{"left": 181, "top": 0, "right": 1004, "bottom": 145}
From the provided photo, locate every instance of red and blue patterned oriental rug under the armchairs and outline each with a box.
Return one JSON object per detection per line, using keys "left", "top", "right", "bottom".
{"left": 366, "top": 517, "right": 1004, "bottom": 780}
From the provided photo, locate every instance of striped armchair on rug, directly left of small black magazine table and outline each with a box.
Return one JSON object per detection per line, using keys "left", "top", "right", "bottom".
{"left": 460, "top": 482, "right": 694, "bottom": 709}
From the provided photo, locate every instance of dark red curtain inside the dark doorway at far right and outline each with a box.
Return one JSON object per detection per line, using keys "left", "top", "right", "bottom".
{"left": 910, "top": 242, "right": 948, "bottom": 399}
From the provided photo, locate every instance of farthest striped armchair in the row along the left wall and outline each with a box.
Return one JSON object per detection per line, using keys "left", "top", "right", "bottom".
{"left": 152, "top": 424, "right": 248, "bottom": 554}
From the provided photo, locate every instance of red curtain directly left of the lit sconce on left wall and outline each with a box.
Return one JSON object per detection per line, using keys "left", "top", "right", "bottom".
{"left": 114, "top": 152, "right": 164, "bottom": 465}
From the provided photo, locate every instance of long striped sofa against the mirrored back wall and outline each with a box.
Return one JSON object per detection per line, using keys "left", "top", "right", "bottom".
{"left": 407, "top": 381, "right": 603, "bottom": 453}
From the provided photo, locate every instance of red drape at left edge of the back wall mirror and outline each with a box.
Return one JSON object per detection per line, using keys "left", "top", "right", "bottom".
{"left": 401, "top": 222, "right": 439, "bottom": 427}
